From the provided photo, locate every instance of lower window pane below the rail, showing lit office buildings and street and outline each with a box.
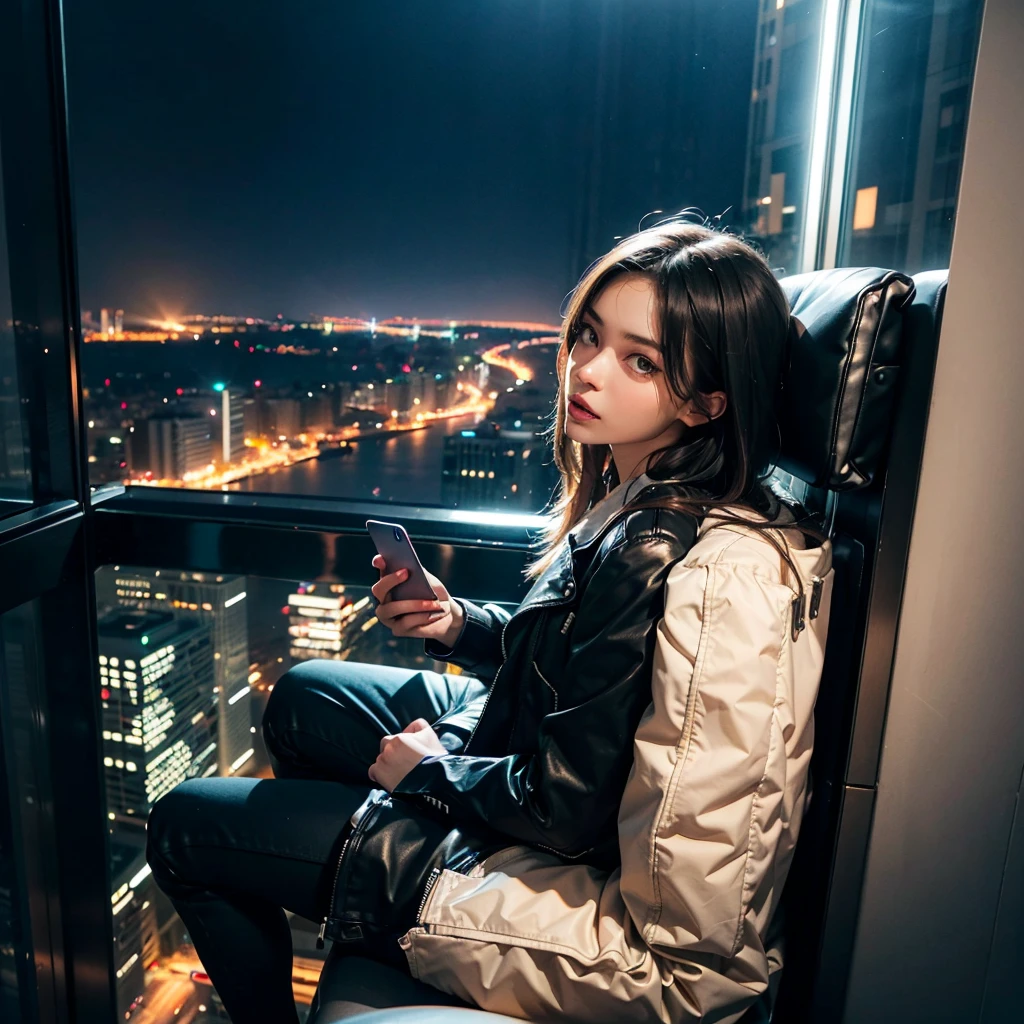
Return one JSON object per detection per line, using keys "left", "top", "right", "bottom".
{"left": 95, "top": 565, "right": 483, "bottom": 1024}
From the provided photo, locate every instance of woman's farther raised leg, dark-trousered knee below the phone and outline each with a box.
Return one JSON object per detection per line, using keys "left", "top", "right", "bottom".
{"left": 263, "top": 660, "right": 487, "bottom": 785}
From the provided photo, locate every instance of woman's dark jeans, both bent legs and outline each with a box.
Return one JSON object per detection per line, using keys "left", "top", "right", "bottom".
{"left": 146, "top": 662, "right": 486, "bottom": 1024}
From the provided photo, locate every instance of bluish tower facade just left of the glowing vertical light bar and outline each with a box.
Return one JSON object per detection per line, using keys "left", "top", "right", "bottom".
{"left": 743, "top": 0, "right": 823, "bottom": 275}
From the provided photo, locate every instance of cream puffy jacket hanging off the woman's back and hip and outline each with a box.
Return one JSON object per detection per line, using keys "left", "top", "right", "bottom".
{"left": 401, "top": 520, "right": 833, "bottom": 1024}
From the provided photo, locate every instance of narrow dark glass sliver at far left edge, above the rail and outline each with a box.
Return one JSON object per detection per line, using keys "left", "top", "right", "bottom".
{"left": 0, "top": 138, "right": 32, "bottom": 515}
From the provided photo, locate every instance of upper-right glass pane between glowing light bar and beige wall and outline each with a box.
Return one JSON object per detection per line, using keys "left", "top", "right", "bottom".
{"left": 839, "top": 0, "right": 982, "bottom": 273}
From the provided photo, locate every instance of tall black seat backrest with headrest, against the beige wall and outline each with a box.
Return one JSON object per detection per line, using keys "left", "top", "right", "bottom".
{"left": 752, "top": 268, "right": 945, "bottom": 1024}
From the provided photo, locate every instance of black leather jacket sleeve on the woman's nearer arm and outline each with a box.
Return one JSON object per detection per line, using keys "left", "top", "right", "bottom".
{"left": 394, "top": 531, "right": 685, "bottom": 857}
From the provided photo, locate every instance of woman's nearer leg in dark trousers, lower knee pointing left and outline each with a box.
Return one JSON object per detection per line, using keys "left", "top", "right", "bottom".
{"left": 146, "top": 778, "right": 369, "bottom": 1024}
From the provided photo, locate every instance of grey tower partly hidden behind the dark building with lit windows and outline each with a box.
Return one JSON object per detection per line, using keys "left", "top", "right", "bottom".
{"left": 96, "top": 565, "right": 253, "bottom": 775}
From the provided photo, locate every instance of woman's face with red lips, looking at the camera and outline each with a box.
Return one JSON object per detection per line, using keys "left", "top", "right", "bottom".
{"left": 565, "top": 273, "right": 705, "bottom": 480}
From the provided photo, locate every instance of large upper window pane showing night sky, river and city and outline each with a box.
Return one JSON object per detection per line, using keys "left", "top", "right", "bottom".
{"left": 66, "top": 0, "right": 821, "bottom": 511}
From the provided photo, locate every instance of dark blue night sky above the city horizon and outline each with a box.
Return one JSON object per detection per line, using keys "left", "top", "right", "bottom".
{"left": 65, "top": 0, "right": 758, "bottom": 323}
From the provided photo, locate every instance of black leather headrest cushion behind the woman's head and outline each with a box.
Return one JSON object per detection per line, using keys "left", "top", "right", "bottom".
{"left": 778, "top": 267, "right": 914, "bottom": 490}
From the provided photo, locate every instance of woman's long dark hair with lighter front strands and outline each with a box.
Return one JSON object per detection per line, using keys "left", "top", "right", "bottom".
{"left": 525, "top": 218, "right": 824, "bottom": 592}
